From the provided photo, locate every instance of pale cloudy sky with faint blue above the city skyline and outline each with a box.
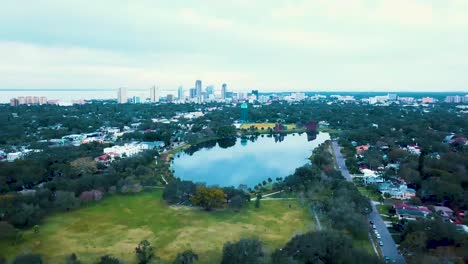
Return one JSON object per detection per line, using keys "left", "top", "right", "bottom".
{"left": 0, "top": 0, "right": 468, "bottom": 92}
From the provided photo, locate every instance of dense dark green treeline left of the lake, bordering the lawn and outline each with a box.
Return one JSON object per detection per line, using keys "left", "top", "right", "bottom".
{"left": 0, "top": 144, "right": 159, "bottom": 227}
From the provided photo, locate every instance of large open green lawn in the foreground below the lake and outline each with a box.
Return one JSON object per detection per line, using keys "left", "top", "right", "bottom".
{"left": 0, "top": 191, "right": 314, "bottom": 263}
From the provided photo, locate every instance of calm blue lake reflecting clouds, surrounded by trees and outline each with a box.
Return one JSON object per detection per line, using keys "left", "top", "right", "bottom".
{"left": 172, "top": 133, "right": 330, "bottom": 187}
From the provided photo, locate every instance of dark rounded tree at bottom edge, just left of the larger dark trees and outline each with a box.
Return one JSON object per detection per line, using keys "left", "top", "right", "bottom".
{"left": 221, "top": 238, "right": 264, "bottom": 264}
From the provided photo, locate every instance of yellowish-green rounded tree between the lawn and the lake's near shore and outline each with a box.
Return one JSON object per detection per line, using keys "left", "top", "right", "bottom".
{"left": 191, "top": 186, "right": 226, "bottom": 211}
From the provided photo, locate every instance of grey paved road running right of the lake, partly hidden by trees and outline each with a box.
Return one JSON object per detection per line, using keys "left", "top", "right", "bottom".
{"left": 332, "top": 141, "right": 406, "bottom": 263}
